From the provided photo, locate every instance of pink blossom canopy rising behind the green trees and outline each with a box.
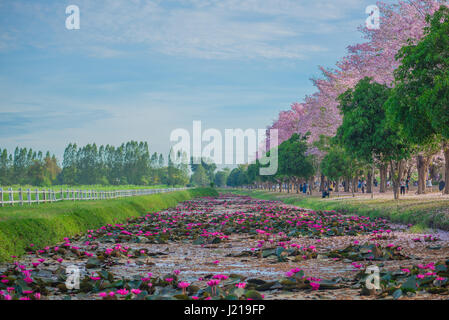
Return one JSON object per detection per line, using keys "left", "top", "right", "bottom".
{"left": 266, "top": 0, "right": 447, "bottom": 154}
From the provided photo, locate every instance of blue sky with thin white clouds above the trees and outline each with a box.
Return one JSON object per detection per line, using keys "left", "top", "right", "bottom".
{"left": 0, "top": 0, "right": 392, "bottom": 158}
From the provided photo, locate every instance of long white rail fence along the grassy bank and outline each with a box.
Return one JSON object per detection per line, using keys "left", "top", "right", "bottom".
{"left": 0, "top": 188, "right": 188, "bottom": 207}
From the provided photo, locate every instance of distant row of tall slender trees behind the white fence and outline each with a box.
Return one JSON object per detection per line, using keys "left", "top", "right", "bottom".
{"left": 0, "top": 141, "right": 201, "bottom": 186}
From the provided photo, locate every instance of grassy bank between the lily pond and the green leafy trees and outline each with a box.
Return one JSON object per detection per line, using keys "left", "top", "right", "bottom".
{"left": 222, "top": 190, "right": 449, "bottom": 231}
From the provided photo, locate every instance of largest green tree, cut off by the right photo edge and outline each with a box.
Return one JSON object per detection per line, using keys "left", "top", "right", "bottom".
{"left": 386, "top": 6, "right": 449, "bottom": 194}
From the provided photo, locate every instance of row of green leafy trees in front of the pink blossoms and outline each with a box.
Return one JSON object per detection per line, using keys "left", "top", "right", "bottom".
{"left": 228, "top": 6, "right": 449, "bottom": 198}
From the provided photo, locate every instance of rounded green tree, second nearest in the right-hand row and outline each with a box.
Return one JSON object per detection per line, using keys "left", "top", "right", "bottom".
{"left": 337, "top": 77, "right": 410, "bottom": 199}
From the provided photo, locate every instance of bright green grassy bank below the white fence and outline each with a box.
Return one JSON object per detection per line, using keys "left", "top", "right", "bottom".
{"left": 0, "top": 188, "right": 217, "bottom": 261}
